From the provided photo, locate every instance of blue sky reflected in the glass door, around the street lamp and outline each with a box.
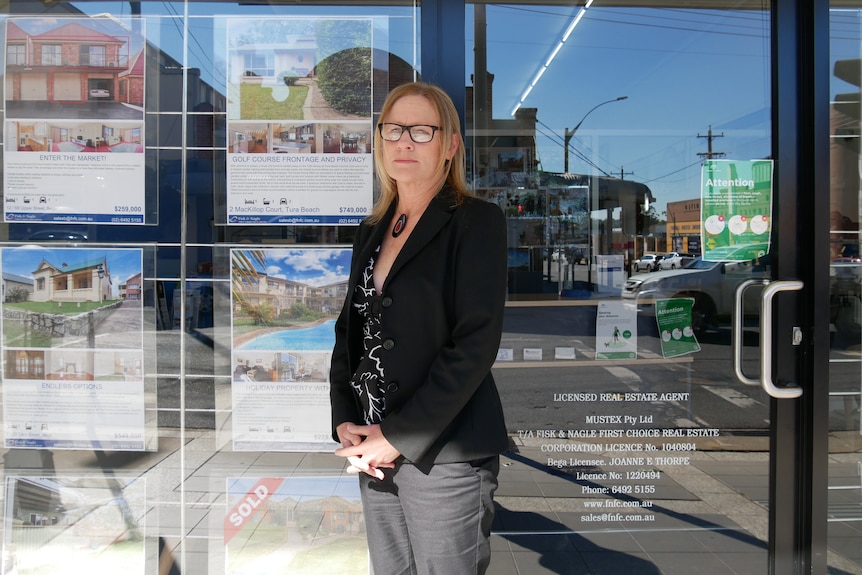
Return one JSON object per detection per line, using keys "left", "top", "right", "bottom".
{"left": 467, "top": 5, "right": 771, "bottom": 211}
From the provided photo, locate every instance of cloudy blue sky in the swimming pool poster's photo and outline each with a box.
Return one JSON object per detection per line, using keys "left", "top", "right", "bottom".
{"left": 236, "top": 248, "right": 351, "bottom": 287}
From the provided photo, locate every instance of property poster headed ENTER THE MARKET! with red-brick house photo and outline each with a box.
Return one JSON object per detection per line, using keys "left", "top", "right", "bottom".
{"left": 3, "top": 17, "right": 147, "bottom": 225}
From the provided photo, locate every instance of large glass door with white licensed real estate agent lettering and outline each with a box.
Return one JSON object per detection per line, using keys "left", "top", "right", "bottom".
{"left": 465, "top": 2, "right": 832, "bottom": 575}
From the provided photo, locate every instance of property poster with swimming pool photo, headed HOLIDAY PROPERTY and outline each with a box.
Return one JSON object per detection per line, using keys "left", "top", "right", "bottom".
{"left": 230, "top": 248, "right": 351, "bottom": 452}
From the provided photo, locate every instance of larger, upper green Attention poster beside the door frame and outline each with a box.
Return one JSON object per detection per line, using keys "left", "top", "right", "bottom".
{"left": 700, "top": 160, "right": 772, "bottom": 262}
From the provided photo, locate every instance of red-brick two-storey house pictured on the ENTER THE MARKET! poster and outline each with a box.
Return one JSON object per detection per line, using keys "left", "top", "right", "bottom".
{"left": 6, "top": 22, "right": 133, "bottom": 105}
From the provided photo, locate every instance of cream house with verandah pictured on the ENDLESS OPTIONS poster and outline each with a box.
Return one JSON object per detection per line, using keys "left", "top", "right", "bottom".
{"left": 31, "top": 258, "right": 111, "bottom": 302}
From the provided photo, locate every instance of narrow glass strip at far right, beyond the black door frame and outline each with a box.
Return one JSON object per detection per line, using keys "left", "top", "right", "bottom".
{"left": 828, "top": 2, "right": 862, "bottom": 573}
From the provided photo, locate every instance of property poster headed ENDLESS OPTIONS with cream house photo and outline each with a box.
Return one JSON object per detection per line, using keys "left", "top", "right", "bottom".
{"left": 0, "top": 247, "right": 145, "bottom": 450}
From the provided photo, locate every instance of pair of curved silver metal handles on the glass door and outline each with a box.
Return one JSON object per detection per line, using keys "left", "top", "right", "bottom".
{"left": 731, "top": 279, "right": 804, "bottom": 399}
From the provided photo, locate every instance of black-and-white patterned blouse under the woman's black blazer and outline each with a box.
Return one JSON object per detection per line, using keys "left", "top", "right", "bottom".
{"left": 350, "top": 246, "right": 386, "bottom": 425}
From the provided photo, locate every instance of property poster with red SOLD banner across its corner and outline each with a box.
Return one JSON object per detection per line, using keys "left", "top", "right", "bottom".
{"left": 224, "top": 475, "right": 368, "bottom": 575}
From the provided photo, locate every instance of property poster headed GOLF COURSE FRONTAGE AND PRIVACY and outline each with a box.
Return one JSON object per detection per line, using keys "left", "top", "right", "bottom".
{"left": 226, "top": 18, "right": 374, "bottom": 225}
